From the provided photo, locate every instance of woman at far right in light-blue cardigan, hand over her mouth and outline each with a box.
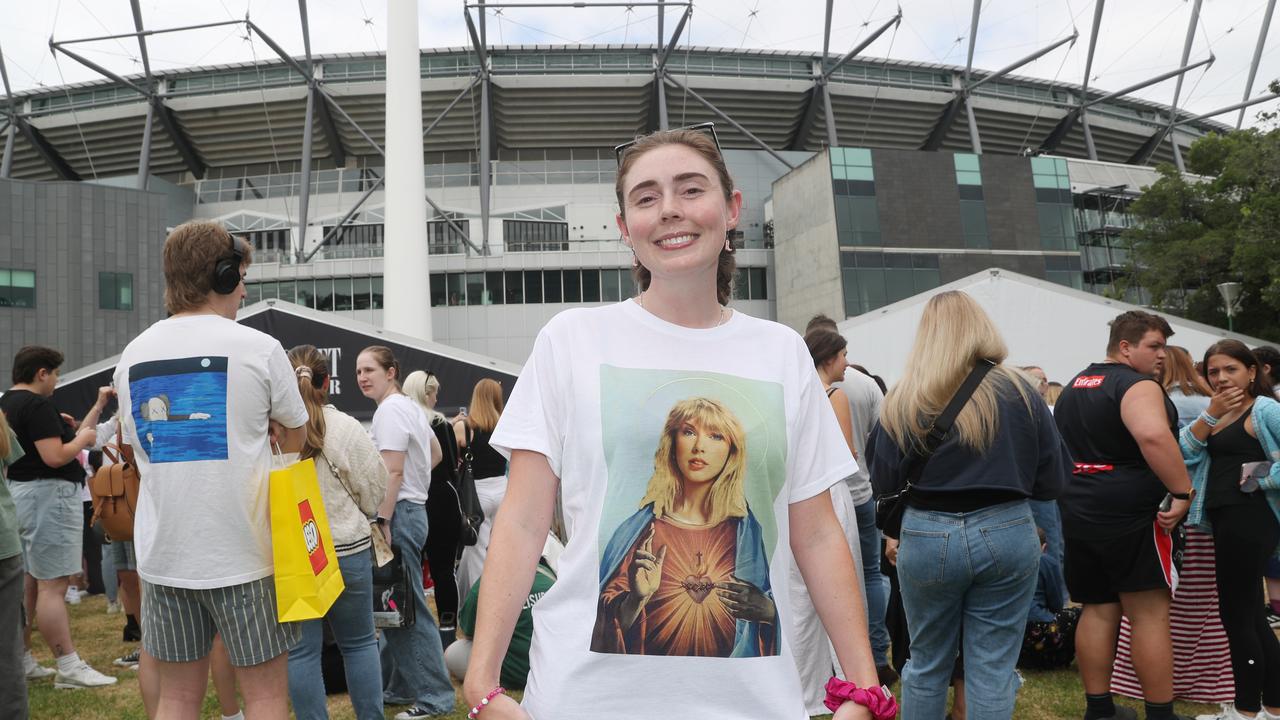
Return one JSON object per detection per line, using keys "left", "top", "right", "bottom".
{"left": 1180, "top": 340, "right": 1280, "bottom": 720}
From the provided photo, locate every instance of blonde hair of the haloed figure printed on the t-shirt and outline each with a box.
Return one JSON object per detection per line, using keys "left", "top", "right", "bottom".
{"left": 640, "top": 397, "right": 746, "bottom": 525}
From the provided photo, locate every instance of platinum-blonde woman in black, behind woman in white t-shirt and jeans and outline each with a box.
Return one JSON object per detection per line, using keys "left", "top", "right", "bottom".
{"left": 404, "top": 370, "right": 462, "bottom": 647}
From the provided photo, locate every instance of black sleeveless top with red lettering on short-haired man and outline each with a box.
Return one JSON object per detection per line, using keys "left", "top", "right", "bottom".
{"left": 1053, "top": 363, "right": 1178, "bottom": 539}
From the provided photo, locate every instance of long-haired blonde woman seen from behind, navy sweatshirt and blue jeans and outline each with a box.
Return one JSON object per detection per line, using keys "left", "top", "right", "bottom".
{"left": 867, "top": 291, "right": 1071, "bottom": 720}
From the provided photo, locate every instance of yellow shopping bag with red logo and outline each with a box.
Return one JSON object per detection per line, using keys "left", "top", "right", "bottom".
{"left": 270, "top": 460, "right": 346, "bottom": 623}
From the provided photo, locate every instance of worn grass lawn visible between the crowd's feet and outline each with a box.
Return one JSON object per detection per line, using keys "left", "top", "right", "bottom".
{"left": 28, "top": 594, "right": 1217, "bottom": 720}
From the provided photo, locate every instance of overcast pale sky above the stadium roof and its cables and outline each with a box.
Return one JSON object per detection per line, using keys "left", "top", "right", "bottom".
{"left": 0, "top": 0, "right": 1280, "bottom": 124}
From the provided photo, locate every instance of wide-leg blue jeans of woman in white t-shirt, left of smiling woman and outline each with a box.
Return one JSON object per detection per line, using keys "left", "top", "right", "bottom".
{"left": 370, "top": 500, "right": 454, "bottom": 715}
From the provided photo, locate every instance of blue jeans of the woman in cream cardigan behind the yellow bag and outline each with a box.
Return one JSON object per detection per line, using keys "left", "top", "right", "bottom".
{"left": 289, "top": 550, "right": 384, "bottom": 720}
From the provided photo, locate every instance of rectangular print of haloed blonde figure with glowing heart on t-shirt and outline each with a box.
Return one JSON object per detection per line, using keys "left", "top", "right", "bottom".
{"left": 591, "top": 366, "right": 786, "bottom": 657}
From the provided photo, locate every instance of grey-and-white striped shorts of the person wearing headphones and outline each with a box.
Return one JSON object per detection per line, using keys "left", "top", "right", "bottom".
{"left": 142, "top": 575, "right": 302, "bottom": 667}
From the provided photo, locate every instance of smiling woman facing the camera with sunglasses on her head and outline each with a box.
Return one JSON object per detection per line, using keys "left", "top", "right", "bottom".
{"left": 463, "top": 128, "right": 896, "bottom": 720}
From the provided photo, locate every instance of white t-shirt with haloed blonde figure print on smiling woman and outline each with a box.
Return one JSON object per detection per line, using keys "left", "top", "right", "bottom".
{"left": 492, "top": 301, "right": 858, "bottom": 720}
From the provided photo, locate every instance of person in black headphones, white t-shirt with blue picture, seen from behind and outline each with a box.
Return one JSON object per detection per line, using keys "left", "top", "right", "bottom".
{"left": 115, "top": 222, "right": 307, "bottom": 720}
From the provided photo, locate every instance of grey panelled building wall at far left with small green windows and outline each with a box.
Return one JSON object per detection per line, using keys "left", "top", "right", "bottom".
{"left": 0, "top": 181, "right": 168, "bottom": 387}
